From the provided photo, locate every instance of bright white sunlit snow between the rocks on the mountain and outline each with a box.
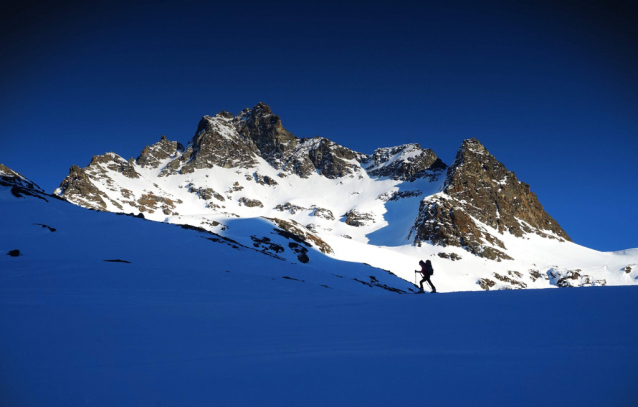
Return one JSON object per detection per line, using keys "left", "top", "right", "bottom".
{"left": 51, "top": 122, "right": 638, "bottom": 292}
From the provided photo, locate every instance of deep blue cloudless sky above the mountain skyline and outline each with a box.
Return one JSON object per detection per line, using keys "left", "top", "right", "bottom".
{"left": 0, "top": 1, "right": 638, "bottom": 250}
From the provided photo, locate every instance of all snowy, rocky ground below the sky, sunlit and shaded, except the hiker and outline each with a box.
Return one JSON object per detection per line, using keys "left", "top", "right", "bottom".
{"left": 0, "top": 107, "right": 638, "bottom": 407}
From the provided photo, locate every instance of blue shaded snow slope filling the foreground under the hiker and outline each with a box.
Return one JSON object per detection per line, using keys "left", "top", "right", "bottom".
{"left": 0, "top": 187, "right": 638, "bottom": 407}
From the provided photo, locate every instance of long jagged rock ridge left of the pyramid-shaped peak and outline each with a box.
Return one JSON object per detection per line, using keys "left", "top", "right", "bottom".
{"left": 55, "top": 103, "right": 445, "bottom": 214}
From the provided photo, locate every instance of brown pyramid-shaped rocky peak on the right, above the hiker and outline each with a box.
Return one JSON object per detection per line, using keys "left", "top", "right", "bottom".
{"left": 412, "top": 139, "right": 571, "bottom": 260}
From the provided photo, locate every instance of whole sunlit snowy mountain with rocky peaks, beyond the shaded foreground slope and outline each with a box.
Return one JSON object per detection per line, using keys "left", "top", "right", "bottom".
{"left": 16, "top": 103, "right": 638, "bottom": 291}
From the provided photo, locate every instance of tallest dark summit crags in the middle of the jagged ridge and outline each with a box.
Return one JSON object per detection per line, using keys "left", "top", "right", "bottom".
{"left": 122, "top": 103, "right": 367, "bottom": 178}
